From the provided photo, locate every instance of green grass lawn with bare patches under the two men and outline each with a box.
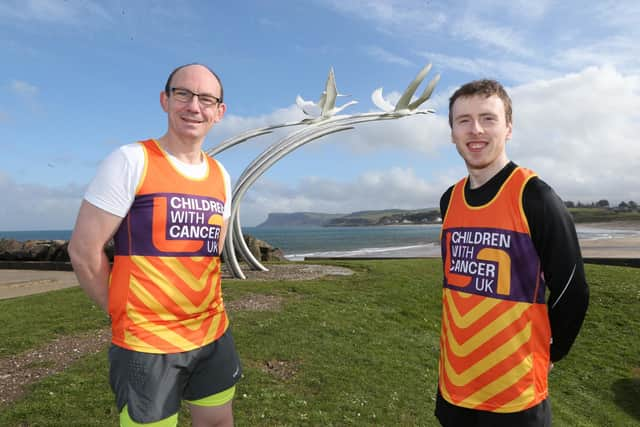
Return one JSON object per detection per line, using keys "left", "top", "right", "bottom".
{"left": 0, "top": 260, "right": 640, "bottom": 427}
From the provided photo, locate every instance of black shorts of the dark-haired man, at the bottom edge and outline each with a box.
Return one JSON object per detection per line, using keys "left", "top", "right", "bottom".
{"left": 435, "top": 390, "right": 551, "bottom": 427}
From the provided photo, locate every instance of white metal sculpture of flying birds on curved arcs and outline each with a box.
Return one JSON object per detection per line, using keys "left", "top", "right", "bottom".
{"left": 207, "top": 64, "right": 440, "bottom": 279}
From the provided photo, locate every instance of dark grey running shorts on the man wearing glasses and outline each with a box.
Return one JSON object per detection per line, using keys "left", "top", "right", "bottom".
{"left": 109, "top": 329, "right": 242, "bottom": 423}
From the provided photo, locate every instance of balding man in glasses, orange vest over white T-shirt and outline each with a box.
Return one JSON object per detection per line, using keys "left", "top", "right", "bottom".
{"left": 69, "top": 64, "right": 241, "bottom": 427}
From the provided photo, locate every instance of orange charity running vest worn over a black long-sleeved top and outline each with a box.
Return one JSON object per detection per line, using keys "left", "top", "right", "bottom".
{"left": 439, "top": 168, "right": 551, "bottom": 412}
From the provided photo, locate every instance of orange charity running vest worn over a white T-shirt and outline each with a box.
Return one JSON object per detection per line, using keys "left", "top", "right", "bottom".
{"left": 109, "top": 140, "right": 229, "bottom": 353}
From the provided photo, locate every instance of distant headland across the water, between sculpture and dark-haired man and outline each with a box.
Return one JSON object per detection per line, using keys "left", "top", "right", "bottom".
{"left": 258, "top": 208, "right": 440, "bottom": 227}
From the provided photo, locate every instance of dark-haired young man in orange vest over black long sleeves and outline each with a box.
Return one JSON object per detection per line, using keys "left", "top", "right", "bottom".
{"left": 435, "top": 80, "right": 589, "bottom": 427}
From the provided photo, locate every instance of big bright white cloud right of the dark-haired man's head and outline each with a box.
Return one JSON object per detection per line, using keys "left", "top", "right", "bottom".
{"left": 507, "top": 67, "right": 640, "bottom": 206}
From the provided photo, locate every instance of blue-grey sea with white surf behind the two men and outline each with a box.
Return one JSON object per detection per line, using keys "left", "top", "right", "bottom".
{"left": 0, "top": 224, "right": 640, "bottom": 261}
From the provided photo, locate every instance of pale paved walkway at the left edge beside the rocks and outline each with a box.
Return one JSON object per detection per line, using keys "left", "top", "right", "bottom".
{"left": 0, "top": 269, "right": 78, "bottom": 299}
